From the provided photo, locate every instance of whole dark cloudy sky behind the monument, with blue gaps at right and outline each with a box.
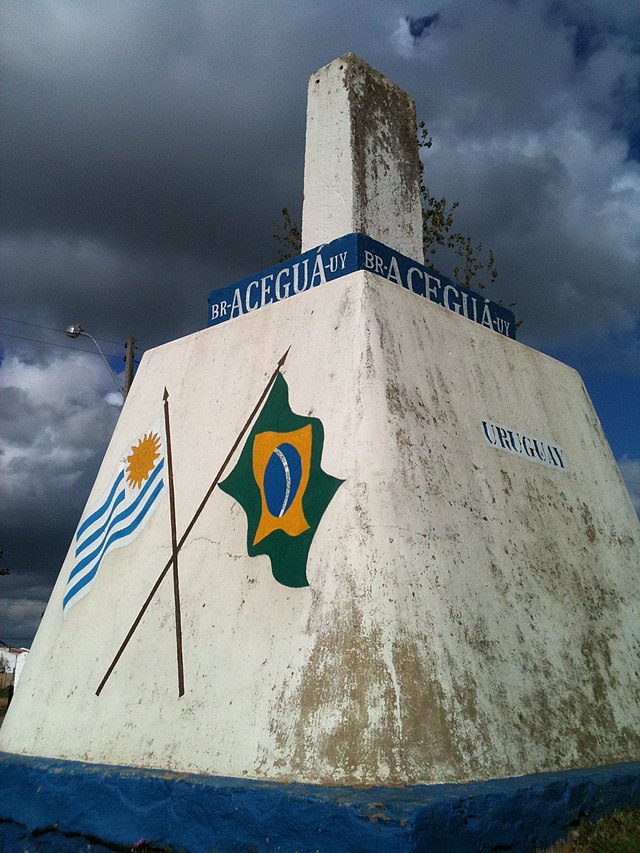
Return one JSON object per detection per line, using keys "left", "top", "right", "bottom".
{"left": 0, "top": 0, "right": 640, "bottom": 645}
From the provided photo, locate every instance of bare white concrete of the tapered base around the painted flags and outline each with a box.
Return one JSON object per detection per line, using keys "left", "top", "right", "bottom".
{"left": 0, "top": 272, "right": 640, "bottom": 784}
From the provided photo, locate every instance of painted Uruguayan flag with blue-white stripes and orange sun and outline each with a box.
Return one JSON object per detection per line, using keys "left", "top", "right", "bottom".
{"left": 62, "top": 419, "right": 167, "bottom": 616}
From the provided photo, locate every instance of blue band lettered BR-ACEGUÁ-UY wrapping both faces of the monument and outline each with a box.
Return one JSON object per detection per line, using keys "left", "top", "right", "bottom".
{"left": 208, "top": 234, "right": 516, "bottom": 339}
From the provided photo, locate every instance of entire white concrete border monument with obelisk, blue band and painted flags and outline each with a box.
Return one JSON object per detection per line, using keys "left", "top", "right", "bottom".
{"left": 0, "top": 54, "right": 640, "bottom": 850}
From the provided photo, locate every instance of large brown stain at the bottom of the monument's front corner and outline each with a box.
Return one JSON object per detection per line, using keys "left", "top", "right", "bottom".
{"left": 274, "top": 595, "right": 468, "bottom": 784}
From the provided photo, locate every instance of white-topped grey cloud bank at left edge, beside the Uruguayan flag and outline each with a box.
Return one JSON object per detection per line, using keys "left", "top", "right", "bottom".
{"left": 0, "top": 346, "right": 118, "bottom": 644}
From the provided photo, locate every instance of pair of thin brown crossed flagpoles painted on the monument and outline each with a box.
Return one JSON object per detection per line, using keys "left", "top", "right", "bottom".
{"left": 96, "top": 347, "right": 291, "bottom": 696}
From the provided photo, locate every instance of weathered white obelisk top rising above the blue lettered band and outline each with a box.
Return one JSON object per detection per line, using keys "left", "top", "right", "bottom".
{"left": 302, "top": 53, "right": 424, "bottom": 261}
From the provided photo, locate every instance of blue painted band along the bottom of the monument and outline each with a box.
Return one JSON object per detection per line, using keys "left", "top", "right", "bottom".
{"left": 0, "top": 753, "right": 640, "bottom": 853}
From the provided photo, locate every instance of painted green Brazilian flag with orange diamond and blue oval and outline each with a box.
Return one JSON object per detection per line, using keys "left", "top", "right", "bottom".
{"left": 220, "top": 373, "right": 343, "bottom": 587}
